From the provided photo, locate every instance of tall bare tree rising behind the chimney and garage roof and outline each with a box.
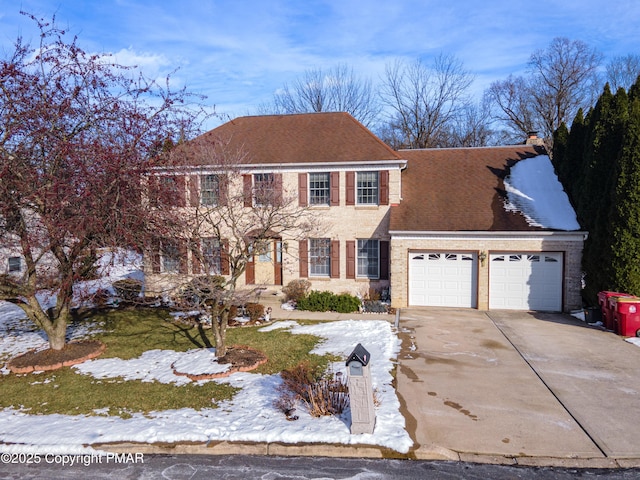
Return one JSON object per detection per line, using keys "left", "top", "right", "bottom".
{"left": 487, "top": 37, "right": 602, "bottom": 141}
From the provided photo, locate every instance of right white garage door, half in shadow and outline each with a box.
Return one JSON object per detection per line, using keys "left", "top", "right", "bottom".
{"left": 489, "top": 252, "right": 562, "bottom": 312}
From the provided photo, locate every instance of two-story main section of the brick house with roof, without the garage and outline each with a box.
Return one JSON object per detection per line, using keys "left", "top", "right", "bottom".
{"left": 145, "top": 113, "right": 406, "bottom": 302}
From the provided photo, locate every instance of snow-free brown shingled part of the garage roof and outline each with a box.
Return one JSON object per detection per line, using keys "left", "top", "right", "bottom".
{"left": 389, "top": 145, "right": 546, "bottom": 232}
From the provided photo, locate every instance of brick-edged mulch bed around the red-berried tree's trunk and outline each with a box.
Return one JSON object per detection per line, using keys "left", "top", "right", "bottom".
{"left": 7, "top": 340, "right": 106, "bottom": 373}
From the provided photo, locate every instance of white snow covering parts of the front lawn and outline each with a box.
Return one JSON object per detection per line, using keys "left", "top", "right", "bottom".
{"left": 0, "top": 302, "right": 412, "bottom": 453}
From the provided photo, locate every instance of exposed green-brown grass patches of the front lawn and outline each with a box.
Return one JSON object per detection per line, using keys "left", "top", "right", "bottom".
{"left": 0, "top": 308, "right": 334, "bottom": 418}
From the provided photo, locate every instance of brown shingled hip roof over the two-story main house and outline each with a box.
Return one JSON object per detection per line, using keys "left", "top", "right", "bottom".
{"left": 180, "top": 112, "right": 400, "bottom": 164}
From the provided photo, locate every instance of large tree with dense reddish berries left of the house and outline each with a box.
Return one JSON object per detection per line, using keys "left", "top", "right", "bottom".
{"left": 0, "top": 15, "right": 205, "bottom": 350}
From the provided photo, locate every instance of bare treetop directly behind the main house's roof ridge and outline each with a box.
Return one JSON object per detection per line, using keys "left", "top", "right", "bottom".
{"left": 261, "top": 64, "right": 380, "bottom": 127}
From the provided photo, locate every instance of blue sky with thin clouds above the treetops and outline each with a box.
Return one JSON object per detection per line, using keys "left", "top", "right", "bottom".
{"left": 0, "top": 0, "right": 640, "bottom": 127}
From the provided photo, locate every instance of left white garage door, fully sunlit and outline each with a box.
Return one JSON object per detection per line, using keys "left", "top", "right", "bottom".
{"left": 409, "top": 252, "right": 477, "bottom": 308}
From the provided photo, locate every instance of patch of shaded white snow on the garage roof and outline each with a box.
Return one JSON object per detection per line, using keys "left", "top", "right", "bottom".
{"left": 504, "top": 155, "right": 580, "bottom": 230}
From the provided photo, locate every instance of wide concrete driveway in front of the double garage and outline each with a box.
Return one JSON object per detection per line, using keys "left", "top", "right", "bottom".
{"left": 398, "top": 308, "right": 640, "bottom": 466}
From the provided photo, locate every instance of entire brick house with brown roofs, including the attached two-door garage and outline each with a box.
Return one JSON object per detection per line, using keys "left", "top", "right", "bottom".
{"left": 145, "top": 113, "right": 584, "bottom": 311}
